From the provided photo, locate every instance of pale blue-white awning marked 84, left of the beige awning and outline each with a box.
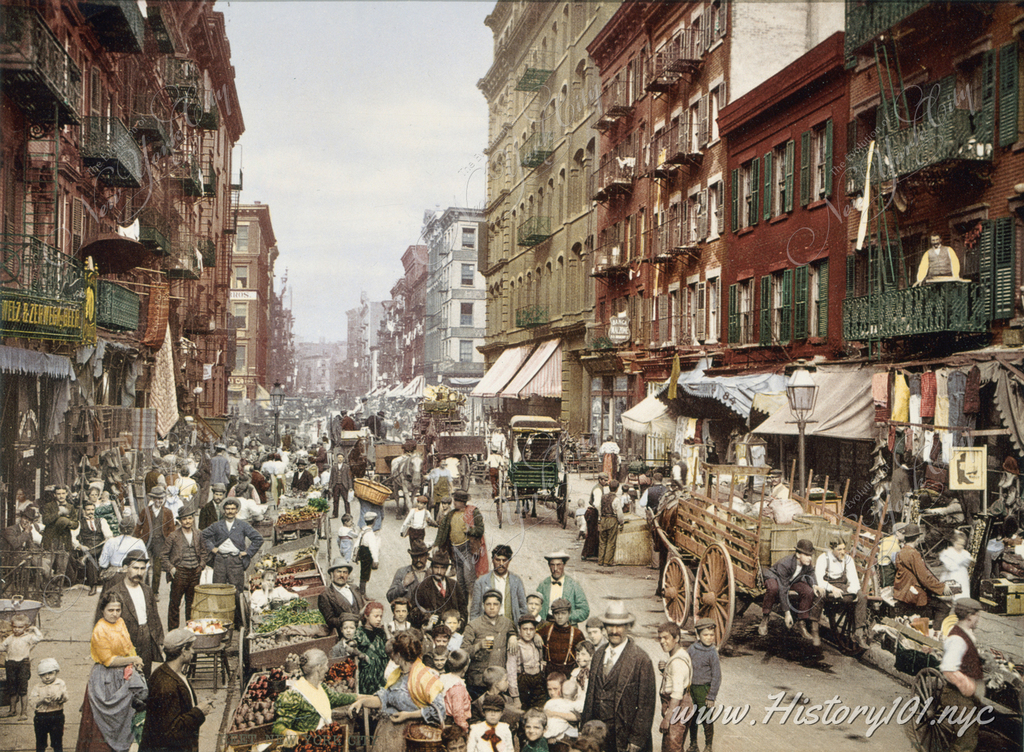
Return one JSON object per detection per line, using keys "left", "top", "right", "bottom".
{"left": 658, "top": 359, "right": 785, "bottom": 420}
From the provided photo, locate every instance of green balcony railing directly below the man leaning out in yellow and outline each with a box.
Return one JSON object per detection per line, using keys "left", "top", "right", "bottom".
{"left": 843, "top": 282, "right": 988, "bottom": 341}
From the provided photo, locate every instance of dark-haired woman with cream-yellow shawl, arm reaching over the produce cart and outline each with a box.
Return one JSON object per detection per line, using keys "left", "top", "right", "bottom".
{"left": 353, "top": 631, "right": 444, "bottom": 752}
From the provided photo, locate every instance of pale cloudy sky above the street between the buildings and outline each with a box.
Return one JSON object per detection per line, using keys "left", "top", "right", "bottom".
{"left": 220, "top": 0, "right": 495, "bottom": 342}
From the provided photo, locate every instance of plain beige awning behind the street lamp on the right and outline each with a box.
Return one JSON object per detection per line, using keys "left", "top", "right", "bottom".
{"left": 754, "top": 368, "right": 878, "bottom": 442}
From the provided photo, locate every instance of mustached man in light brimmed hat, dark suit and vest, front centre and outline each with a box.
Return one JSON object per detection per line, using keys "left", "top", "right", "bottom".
{"left": 582, "top": 600, "right": 657, "bottom": 752}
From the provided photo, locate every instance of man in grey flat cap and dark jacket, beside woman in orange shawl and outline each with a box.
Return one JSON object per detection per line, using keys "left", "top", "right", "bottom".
{"left": 138, "top": 629, "right": 213, "bottom": 752}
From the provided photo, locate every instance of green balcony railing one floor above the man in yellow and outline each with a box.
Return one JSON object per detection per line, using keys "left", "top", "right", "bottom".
{"left": 846, "top": 110, "right": 992, "bottom": 194}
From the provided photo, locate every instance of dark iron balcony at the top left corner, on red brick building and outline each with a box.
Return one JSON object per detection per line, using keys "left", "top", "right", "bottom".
{"left": 0, "top": 6, "right": 82, "bottom": 125}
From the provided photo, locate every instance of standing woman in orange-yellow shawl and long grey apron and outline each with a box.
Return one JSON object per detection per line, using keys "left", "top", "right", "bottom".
{"left": 75, "top": 590, "right": 148, "bottom": 752}
